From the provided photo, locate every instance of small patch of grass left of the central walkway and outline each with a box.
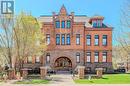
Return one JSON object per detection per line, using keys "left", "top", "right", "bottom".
{"left": 15, "top": 79, "right": 49, "bottom": 84}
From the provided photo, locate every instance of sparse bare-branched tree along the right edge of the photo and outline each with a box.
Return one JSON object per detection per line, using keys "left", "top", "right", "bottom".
{"left": 117, "top": 0, "right": 130, "bottom": 70}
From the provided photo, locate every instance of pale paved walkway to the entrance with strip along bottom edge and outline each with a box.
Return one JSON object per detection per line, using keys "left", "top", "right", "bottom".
{"left": 0, "top": 74, "right": 130, "bottom": 86}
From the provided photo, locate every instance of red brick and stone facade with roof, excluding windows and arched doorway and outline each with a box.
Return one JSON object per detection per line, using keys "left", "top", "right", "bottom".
{"left": 25, "top": 6, "right": 112, "bottom": 72}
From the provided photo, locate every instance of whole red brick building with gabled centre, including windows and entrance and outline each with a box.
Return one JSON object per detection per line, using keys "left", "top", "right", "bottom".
{"left": 23, "top": 6, "right": 112, "bottom": 72}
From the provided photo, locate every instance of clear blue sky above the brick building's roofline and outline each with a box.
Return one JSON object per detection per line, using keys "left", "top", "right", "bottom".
{"left": 15, "top": 0, "right": 125, "bottom": 45}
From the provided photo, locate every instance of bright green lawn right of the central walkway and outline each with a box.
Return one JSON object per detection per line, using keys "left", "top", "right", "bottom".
{"left": 74, "top": 74, "right": 130, "bottom": 84}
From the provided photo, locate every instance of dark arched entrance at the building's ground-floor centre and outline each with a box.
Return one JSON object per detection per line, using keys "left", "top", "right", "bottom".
{"left": 54, "top": 57, "right": 72, "bottom": 71}
